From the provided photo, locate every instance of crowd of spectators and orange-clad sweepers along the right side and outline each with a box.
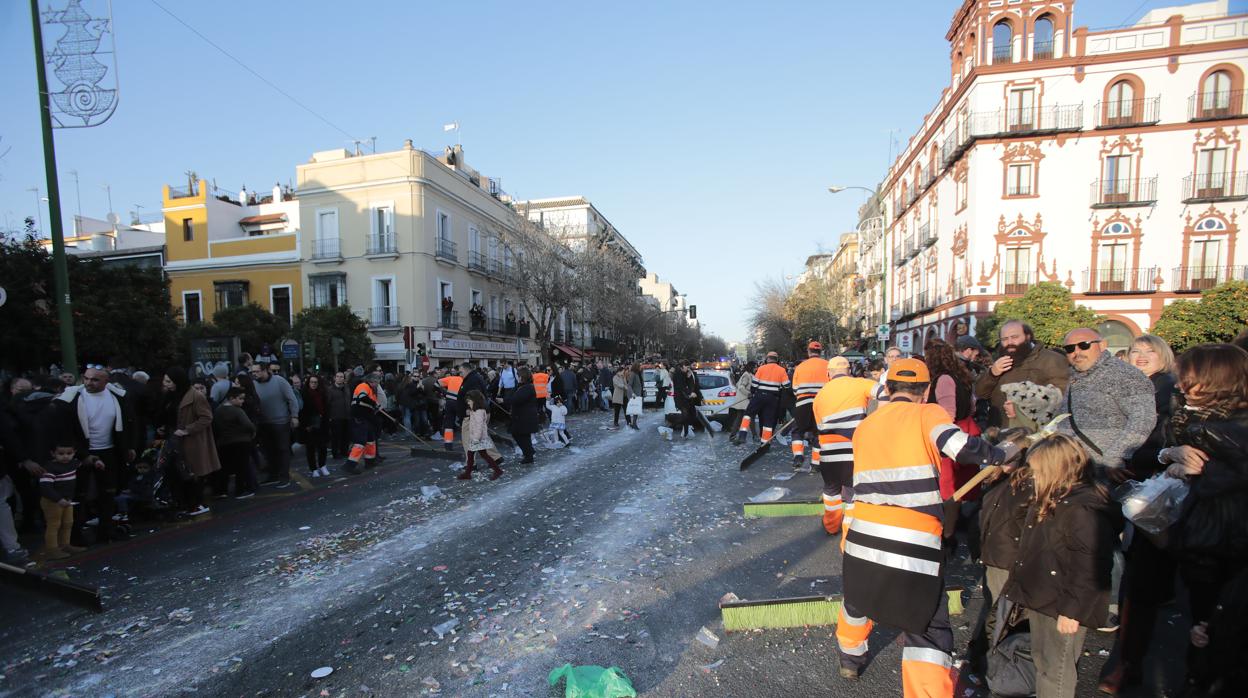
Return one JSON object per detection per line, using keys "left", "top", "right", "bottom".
{"left": 734, "top": 320, "right": 1248, "bottom": 698}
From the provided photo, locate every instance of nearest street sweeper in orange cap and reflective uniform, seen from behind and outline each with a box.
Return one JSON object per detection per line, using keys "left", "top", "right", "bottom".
{"left": 836, "top": 358, "right": 1021, "bottom": 698}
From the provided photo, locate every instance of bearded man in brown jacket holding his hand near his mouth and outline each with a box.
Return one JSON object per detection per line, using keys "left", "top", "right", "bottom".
{"left": 975, "top": 320, "right": 1070, "bottom": 427}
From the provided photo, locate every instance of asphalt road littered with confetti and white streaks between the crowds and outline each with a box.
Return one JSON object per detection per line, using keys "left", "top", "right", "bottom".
{"left": 0, "top": 413, "right": 1182, "bottom": 698}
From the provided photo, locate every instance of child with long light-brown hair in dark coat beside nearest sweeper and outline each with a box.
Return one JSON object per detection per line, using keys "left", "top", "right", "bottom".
{"left": 1005, "top": 435, "right": 1117, "bottom": 698}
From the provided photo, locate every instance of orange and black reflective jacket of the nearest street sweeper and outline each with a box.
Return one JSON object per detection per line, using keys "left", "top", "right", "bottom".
{"left": 848, "top": 399, "right": 965, "bottom": 633}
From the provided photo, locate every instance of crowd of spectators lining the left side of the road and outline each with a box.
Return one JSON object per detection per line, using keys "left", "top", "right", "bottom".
{"left": 0, "top": 348, "right": 678, "bottom": 562}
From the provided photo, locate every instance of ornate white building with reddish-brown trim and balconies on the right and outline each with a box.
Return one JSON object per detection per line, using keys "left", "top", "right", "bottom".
{"left": 857, "top": 0, "right": 1248, "bottom": 351}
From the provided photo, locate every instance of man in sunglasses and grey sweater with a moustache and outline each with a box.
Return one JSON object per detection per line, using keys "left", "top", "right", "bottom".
{"left": 1060, "top": 327, "right": 1157, "bottom": 474}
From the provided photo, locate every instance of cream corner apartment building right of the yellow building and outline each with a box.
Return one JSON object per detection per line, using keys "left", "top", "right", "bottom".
{"left": 296, "top": 141, "right": 538, "bottom": 368}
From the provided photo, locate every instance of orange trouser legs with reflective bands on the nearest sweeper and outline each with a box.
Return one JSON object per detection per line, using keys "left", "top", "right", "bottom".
{"left": 836, "top": 594, "right": 957, "bottom": 698}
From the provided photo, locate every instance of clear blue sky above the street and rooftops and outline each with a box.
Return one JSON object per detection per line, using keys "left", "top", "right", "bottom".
{"left": 0, "top": 0, "right": 1248, "bottom": 340}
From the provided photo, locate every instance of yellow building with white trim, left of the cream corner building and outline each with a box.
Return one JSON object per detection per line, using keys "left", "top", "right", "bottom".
{"left": 161, "top": 177, "right": 303, "bottom": 324}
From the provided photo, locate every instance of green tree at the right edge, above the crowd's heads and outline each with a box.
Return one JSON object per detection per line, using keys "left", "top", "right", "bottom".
{"left": 1152, "top": 281, "right": 1248, "bottom": 353}
